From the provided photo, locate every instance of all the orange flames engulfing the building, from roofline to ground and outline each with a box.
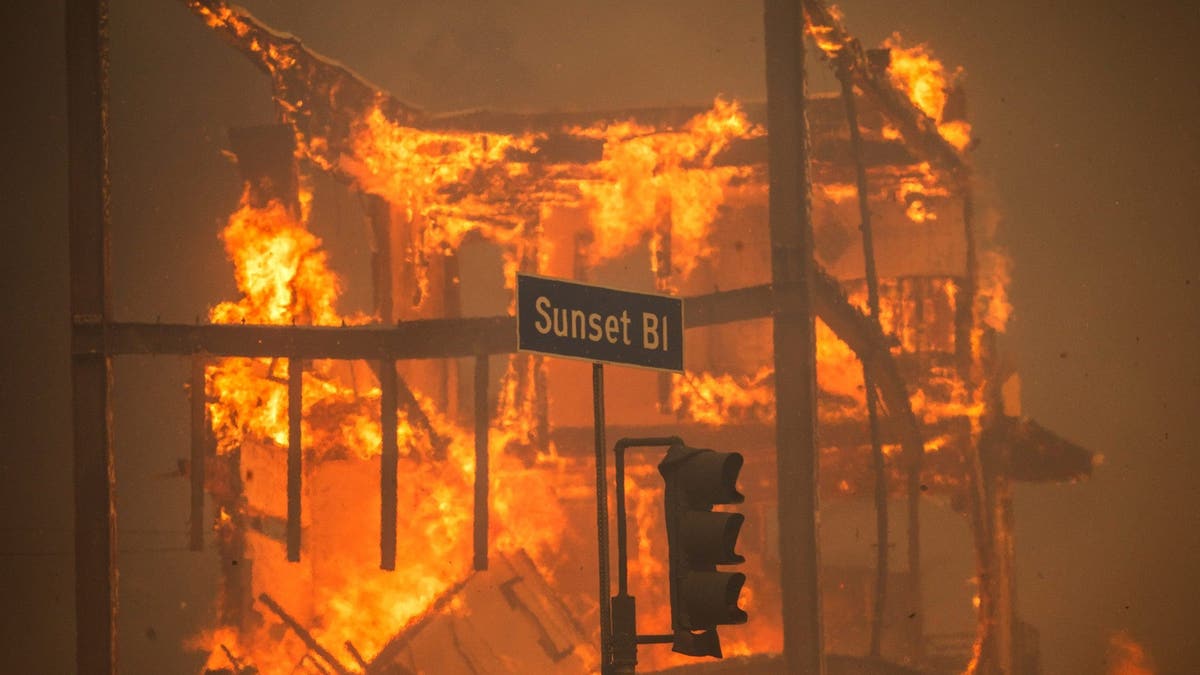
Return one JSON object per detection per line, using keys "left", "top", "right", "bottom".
{"left": 184, "top": 2, "right": 1032, "bottom": 673}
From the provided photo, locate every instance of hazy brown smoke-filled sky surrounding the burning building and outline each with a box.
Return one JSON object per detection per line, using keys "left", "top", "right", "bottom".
{"left": 0, "top": 0, "right": 1200, "bottom": 674}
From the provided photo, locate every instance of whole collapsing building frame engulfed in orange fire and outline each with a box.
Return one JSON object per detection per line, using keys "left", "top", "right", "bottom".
{"left": 180, "top": 0, "right": 1091, "bottom": 673}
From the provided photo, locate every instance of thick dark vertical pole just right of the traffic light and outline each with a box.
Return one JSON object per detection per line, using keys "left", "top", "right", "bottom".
{"left": 764, "top": 0, "right": 824, "bottom": 675}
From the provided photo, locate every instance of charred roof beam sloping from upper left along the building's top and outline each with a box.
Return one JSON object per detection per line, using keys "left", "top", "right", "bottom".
{"left": 186, "top": 0, "right": 926, "bottom": 180}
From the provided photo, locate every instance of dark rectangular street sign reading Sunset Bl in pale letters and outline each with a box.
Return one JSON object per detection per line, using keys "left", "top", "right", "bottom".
{"left": 517, "top": 274, "right": 683, "bottom": 371}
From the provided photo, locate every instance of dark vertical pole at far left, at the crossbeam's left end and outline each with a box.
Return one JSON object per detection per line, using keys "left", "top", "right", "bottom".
{"left": 65, "top": 0, "right": 116, "bottom": 674}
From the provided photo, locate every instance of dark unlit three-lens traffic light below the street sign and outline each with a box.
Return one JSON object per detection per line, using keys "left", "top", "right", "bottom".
{"left": 659, "top": 442, "right": 746, "bottom": 658}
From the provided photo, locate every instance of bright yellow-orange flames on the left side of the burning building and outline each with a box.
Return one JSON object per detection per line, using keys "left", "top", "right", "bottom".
{"left": 198, "top": 187, "right": 576, "bottom": 673}
